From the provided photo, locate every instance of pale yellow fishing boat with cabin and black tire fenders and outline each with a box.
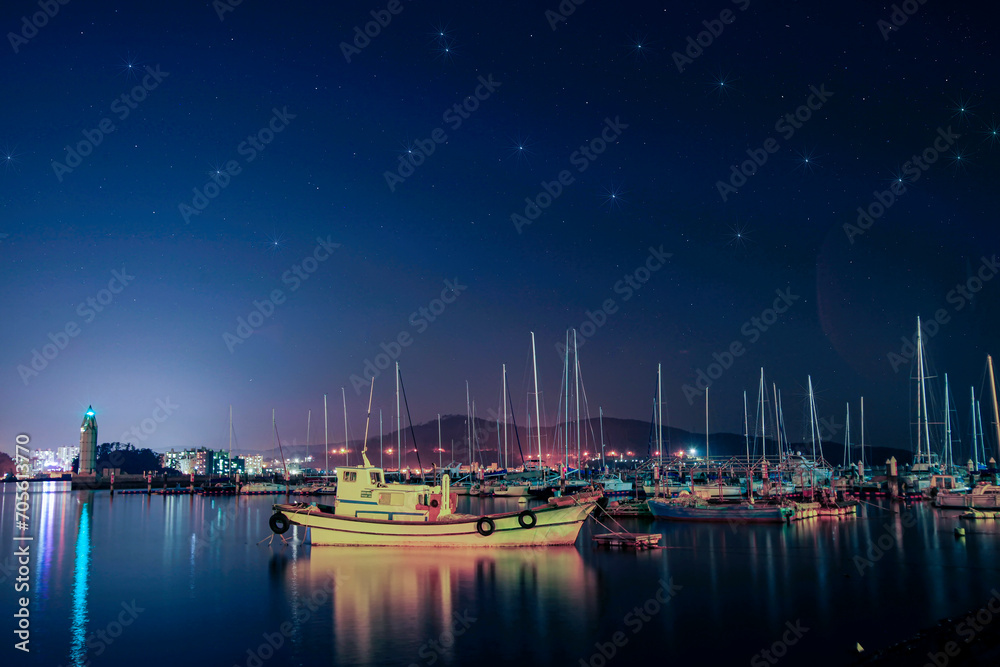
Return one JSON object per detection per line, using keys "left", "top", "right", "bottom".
{"left": 269, "top": 452, "right": 601, "bottom": 547}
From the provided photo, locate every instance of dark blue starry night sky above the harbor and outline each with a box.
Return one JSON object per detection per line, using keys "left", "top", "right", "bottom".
{"left": 0, "top": 0, "right": 1000, "bottom": 460}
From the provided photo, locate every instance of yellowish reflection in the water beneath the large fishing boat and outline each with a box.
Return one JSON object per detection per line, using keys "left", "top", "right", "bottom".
{"left": 298, "top": 547, "right": 597, "bottom": 664}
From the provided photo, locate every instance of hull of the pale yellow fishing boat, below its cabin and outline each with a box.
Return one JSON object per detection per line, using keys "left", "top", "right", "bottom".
{"left": 274, "top": 497, "right": 598, "bottom": 548}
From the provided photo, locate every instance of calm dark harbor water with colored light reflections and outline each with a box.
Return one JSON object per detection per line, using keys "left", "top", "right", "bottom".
{"left": 0, "top": 484, "right": 1000, "bottom": 667}
